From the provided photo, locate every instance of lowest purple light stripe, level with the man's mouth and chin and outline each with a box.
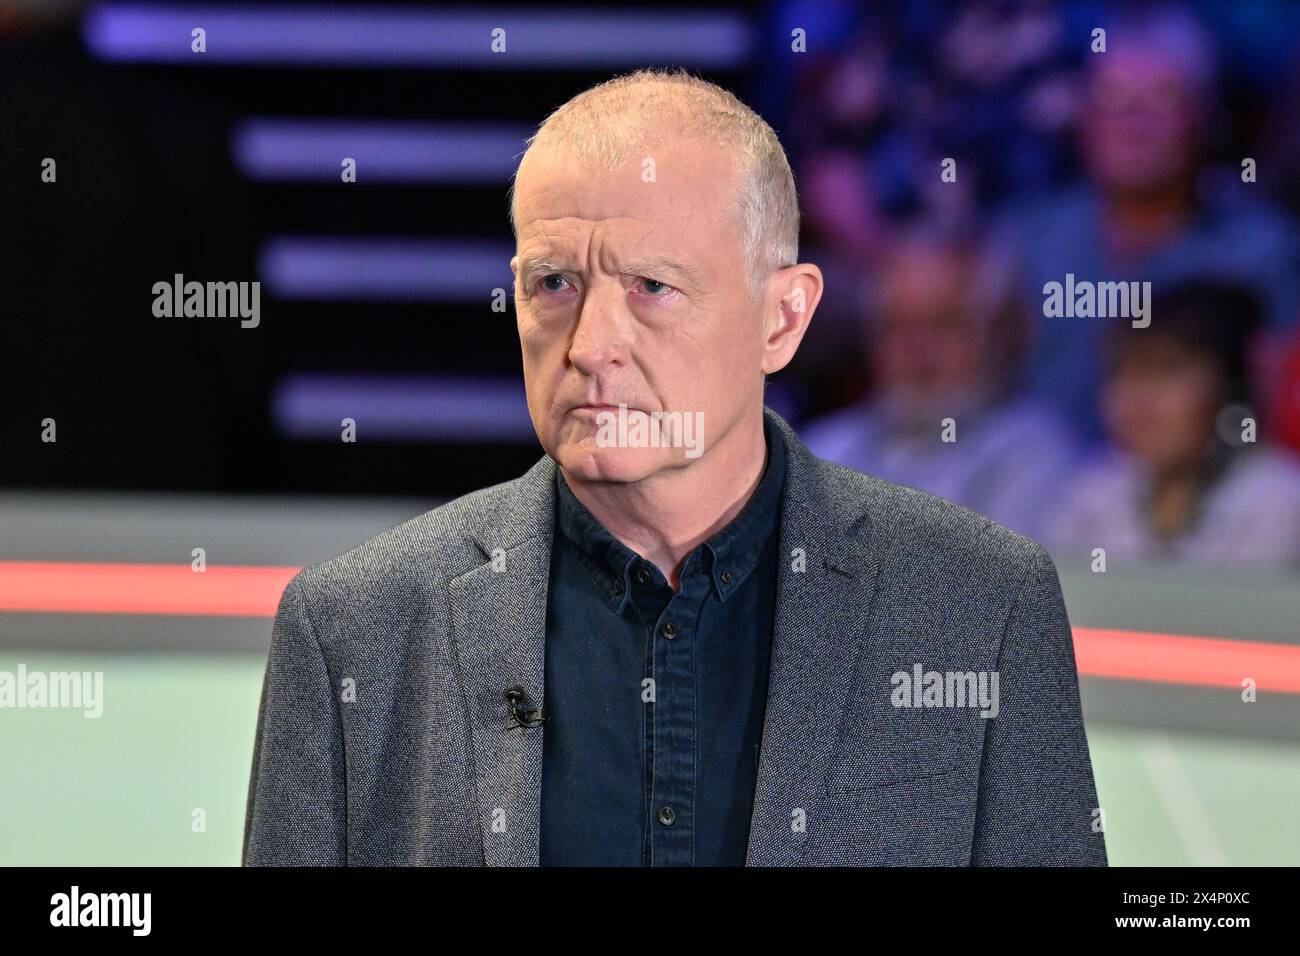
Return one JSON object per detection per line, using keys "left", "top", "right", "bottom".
{"left": 272, "top": 373, "right": 537, "bottom": 442}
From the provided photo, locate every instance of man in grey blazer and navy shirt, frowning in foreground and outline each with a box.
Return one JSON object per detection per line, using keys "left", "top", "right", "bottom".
{"left": 244, "top": 72, "right": 1105, "bottom": 865}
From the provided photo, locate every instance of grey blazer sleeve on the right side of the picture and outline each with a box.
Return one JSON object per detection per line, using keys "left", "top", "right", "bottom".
{"left": 971, "top": 545, "right": 1106, "bottom": 866}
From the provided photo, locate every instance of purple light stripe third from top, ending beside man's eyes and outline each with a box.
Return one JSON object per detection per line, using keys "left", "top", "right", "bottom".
{"left": 259, "top": 235, "right": 515, "bottom": 300}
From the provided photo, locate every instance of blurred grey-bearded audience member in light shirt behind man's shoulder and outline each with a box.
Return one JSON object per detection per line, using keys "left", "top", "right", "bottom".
{"left": 805, "top": 233, "right": 1074, "bottom": 536}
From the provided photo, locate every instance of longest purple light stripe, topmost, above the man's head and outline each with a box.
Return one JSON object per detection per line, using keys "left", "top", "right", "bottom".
{"left": 82, "top": 3, "right": 753, "bottom": 68}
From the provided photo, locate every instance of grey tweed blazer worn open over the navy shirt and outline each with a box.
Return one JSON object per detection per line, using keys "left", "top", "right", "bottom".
{"left": 243, "top": 411, "right": 1106, "bottom": 866}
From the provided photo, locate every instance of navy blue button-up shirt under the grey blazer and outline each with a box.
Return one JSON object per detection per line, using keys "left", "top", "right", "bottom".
{"left": 541, "top": 424, "right": 785, "bottom": 866}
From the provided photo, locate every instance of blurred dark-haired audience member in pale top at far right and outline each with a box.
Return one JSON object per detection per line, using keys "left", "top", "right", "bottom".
{"left": 1045, "top": 281, "right": 1300, "bottom": 563}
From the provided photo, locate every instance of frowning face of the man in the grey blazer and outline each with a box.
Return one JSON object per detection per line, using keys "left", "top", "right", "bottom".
{"left": 511, "top": 140, "right": 764, "bottom": 483}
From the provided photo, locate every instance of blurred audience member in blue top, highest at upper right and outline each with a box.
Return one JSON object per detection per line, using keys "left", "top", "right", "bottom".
{"left": 1010, "top": 5, "right": 1297, "bottom": 440}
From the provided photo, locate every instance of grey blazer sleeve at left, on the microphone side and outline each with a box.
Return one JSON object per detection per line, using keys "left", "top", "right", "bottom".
{"left": 243, "top": 575, "right": 347, "bottom": 866}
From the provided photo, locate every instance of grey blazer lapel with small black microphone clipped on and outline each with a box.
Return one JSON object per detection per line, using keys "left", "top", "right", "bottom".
{"left": 447, "top": 458, "right": 555, "bottom": 866}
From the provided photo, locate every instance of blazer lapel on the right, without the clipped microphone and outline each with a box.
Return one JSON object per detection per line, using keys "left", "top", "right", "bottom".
{"left": 746, "top": 412, "right": 884, "bottom": 866}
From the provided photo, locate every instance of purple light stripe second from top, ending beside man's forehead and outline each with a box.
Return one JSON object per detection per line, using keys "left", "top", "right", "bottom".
{"left": 230, "top": 118, "right": 532, "bottom": 185}
